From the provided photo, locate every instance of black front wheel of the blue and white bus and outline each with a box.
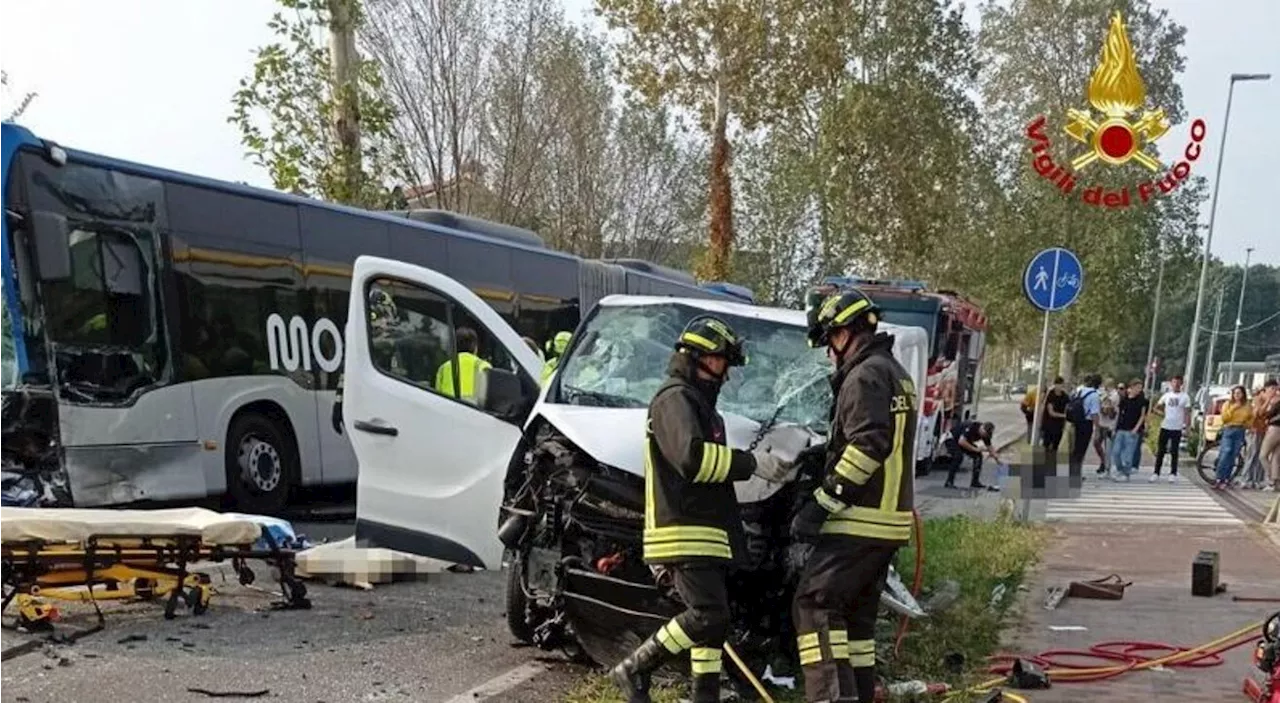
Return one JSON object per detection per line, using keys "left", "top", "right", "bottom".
{"left": 227, "top": 412, "right": 297, "bottom": 515}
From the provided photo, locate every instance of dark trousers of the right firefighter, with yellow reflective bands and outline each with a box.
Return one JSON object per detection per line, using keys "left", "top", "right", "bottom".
{"left": 792, "top": 537, "right": 897, "bottom": 703}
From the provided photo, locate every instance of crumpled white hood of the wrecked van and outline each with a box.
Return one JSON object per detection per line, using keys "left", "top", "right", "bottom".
{"left": 535, "top": 402, "right": 822, "bottom": 503}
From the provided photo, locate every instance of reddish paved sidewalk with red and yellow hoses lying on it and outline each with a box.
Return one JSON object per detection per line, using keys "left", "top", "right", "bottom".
{"left": 1007, "top": 524, "right": 1280, "bottom": 703}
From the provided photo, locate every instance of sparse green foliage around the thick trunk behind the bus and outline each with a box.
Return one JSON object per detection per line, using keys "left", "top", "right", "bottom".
{"left": 228, "top": 0, "right": 398, "bottom": 207}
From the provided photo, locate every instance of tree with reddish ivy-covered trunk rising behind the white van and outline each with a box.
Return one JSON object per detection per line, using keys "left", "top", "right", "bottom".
{"left": 596, "top": 0, "right": 842, "bottom": 279}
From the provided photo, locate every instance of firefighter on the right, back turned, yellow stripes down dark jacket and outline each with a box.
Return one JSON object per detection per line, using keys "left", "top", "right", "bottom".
{"left": 791, "top": 289, "right": 916, "bottom": 703}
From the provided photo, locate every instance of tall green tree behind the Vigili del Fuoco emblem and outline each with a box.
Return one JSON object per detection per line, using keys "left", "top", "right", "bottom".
{"left": 979, "top": 0, "right": 1204, "bottom": 375}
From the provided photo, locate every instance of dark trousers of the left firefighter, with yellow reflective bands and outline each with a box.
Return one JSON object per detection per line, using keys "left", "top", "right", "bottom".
{"left": 657, "top": 561, "right": 730, "bottom": 703}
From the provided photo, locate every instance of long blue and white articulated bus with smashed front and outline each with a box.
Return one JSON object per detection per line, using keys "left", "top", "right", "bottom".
{"left": 0, "top": 123, "right": 750, "bottom": 512}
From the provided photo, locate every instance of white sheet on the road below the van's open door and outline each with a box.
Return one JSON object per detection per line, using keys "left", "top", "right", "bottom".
{"left": 297, "top": 537, "right": 451, "bottom": 589}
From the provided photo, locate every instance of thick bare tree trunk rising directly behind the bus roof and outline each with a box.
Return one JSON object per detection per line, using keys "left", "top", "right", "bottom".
{"left": 329, "top": 0, "right": 364, "bottom": 205}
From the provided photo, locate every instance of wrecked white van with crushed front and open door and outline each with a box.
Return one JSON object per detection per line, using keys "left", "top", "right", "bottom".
{"left": 344, "top": 257, "right": 928, "bottom": 671}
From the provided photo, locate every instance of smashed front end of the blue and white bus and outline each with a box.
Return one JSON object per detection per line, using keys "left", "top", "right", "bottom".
{"left": 0, "top": 124, "right": 177, "bottom": 506}
